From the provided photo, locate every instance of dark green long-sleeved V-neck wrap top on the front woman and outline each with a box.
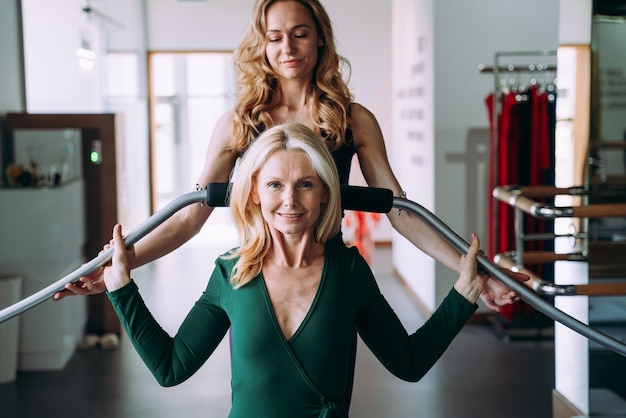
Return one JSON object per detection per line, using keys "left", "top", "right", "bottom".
{"left": 108, "top": 243, "right": 477, "bottom": 418}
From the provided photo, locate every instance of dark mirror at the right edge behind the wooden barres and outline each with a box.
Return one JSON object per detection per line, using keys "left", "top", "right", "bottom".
{"left": 587, "top": 0, "right": 626, "bottom": 407}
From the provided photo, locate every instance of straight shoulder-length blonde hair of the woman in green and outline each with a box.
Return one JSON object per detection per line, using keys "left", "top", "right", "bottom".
{"left": 224, "top": 123, "right": 341, "bottom": 288}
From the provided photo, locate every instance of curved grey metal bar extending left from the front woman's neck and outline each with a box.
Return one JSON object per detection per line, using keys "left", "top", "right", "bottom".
{"left": 0, "top": 188, "right": 210, "bottom": 323}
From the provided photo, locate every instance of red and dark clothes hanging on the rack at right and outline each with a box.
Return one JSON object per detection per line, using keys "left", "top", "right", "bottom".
{"left": 485, "top": 84, "right": 556, "bottom": 321}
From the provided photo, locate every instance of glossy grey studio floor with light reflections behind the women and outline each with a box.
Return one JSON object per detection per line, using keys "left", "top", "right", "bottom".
{"left": 0, "top": 246, "right": 554, "bottom": 418}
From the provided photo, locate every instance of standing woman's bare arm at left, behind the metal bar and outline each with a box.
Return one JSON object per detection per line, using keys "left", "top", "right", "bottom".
{"left": 54, "top": 111, "right": 237, "bottom": 300}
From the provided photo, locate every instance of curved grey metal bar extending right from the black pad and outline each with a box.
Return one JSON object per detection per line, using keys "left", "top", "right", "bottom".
{"left": 393, "top": 197, "right": 626, "bottom": 356}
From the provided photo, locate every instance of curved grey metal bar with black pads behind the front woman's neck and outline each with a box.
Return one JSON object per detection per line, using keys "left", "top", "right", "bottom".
{"left": 0, "top": 183, "right": 626, "bottom": 356}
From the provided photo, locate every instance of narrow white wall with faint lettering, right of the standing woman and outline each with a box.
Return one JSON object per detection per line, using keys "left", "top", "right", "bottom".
{"left": 392, "top": 0, "right": 437, "bottom": 312}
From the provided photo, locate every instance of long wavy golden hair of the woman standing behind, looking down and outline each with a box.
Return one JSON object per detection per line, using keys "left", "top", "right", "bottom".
{"left": 230, "top": 0, "right": 352, "bottom": 153}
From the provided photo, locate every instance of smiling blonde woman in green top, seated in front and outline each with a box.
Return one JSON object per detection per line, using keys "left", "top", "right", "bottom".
{"left": 104, "top": 124, "right": 487, "bottom": 418}
